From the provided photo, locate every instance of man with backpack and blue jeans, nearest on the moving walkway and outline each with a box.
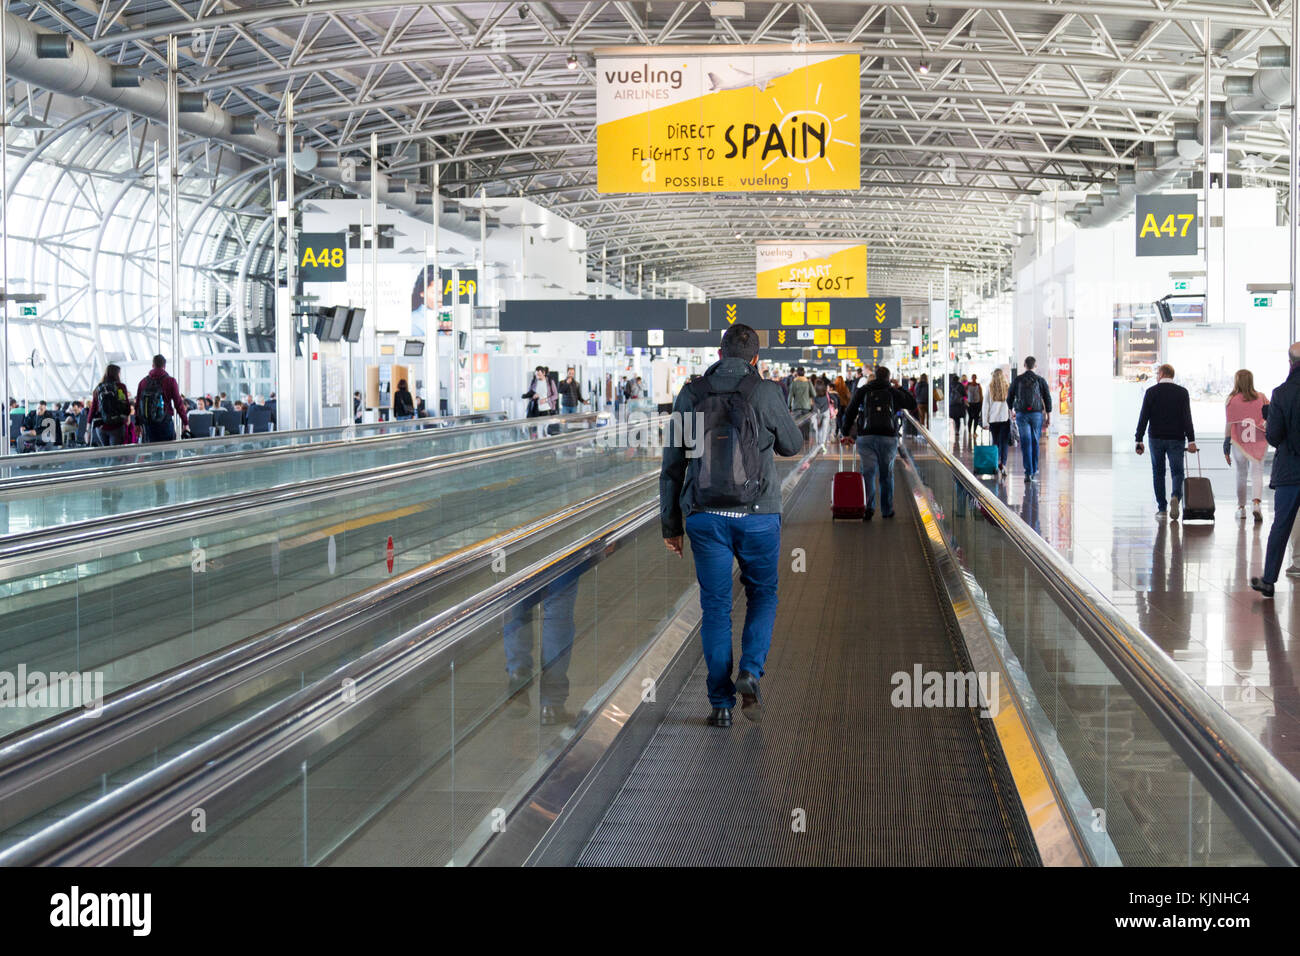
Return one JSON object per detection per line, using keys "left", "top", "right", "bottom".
{"left": 659, "top": 324, "right": 803, "bottom": 727}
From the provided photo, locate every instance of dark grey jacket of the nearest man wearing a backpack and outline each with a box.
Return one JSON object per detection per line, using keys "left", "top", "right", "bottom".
{"left": 659, "top": 359, "right": 803, "bottom": 537}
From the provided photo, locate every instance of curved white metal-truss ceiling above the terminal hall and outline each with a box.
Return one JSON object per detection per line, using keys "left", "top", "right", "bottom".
{"left": 2, "top": 0, "right": 1291, "bottom": 316}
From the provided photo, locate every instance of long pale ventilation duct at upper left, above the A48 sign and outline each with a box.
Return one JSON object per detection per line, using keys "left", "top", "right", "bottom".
{"left": 0, "top": 13, "right": 478, "bottom": 241}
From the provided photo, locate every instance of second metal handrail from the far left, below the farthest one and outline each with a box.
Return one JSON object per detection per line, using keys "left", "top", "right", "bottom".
{"left": 0, "top": 419, "right": 644, "bottom": 580}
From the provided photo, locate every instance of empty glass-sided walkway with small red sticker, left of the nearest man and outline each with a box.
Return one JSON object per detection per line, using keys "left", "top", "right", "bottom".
{"left": 0, "top": 413, "right": 637, "bottom": 734}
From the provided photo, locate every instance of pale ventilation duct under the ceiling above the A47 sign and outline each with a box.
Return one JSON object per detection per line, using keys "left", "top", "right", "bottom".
{"left": 1066, "top": 47, "right": 1291, "bottom": 229}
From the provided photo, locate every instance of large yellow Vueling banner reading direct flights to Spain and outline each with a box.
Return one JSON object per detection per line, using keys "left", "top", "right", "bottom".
{"left": 595, "top": 47, "right": 862, "bottom": 193}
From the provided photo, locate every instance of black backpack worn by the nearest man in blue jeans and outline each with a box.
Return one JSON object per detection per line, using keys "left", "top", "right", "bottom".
{"left": 688, "top": 375, "right": 763, "bottom": 509}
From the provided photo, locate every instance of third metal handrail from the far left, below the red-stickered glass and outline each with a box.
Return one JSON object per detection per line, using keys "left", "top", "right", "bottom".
{"left": 0, "top": 470, "right": 658, "bottom": 830}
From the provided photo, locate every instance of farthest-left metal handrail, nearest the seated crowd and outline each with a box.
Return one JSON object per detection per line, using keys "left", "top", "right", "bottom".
{"left": 0, "top": 414, "right": 559, "bottom": 499}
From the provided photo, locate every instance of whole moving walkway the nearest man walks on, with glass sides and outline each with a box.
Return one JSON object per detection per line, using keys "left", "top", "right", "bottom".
{"left": 0, "top": 418, "right": 1300, "bottom": 865}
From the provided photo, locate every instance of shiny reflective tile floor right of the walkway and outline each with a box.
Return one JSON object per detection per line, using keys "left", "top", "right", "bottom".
{"left": 959, "top": 429, "right": 1300, "bottom": 775}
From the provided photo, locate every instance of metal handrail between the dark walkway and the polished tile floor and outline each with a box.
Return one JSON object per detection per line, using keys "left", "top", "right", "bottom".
{"left": 904, "top": 412, "right": 1300, "bottom": 865}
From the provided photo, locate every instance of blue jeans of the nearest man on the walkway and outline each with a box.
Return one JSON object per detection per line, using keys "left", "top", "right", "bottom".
{"left": 686, "top": 511, "right": 781, "bottom": 708}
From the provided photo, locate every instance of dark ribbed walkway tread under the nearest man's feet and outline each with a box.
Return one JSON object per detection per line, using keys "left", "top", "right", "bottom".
{"left": 576, "top": 460, "right": 1040, "bottom": 866}
